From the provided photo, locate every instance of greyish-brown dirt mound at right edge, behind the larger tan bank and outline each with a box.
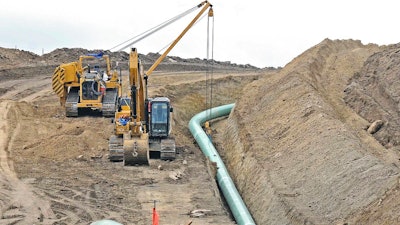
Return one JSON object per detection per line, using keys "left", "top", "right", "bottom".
{"left": 345, "top": 45, "right": 400, "bottom": 150}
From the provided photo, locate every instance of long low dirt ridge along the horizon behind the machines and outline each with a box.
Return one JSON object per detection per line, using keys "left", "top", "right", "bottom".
{"left": 0, "top": 48, "right": 262, "bottom": 83}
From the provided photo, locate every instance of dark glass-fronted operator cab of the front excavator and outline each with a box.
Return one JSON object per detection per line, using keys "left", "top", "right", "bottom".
{"left": 149, "top": 97, "right": 173, "bottom": 138}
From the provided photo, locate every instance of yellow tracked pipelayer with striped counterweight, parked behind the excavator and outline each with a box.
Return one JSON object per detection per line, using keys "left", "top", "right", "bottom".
{"left": 52, "top": 53, "right": 121, "bottom": 117}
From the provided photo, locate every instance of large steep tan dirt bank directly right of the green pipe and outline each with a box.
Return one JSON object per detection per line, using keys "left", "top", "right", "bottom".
{"left": 219, "top": 40, "right": 399, "bottom": 224}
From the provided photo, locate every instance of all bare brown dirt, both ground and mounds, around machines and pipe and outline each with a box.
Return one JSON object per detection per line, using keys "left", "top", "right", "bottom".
{"left": 0, "top": 39, "right": 400, "bottom": 224}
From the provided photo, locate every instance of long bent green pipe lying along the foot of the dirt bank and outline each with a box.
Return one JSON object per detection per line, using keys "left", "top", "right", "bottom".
{"left": 189, "top": 104, "right": 255, "bottom": 225}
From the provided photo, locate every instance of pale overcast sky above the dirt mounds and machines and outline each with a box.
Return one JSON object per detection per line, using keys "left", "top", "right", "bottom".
{"left": 0, "top": 0, "right": 400, "bottom": 67}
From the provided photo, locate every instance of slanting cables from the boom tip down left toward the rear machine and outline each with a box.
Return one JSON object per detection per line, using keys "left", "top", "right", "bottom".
{"left": 109, "top": 5, "right": 200, "bottom": 51}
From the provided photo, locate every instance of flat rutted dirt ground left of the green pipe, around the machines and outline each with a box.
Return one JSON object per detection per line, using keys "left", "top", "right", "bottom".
{"left": 0, "top": 45, "right": 260, "bottom": 224}
